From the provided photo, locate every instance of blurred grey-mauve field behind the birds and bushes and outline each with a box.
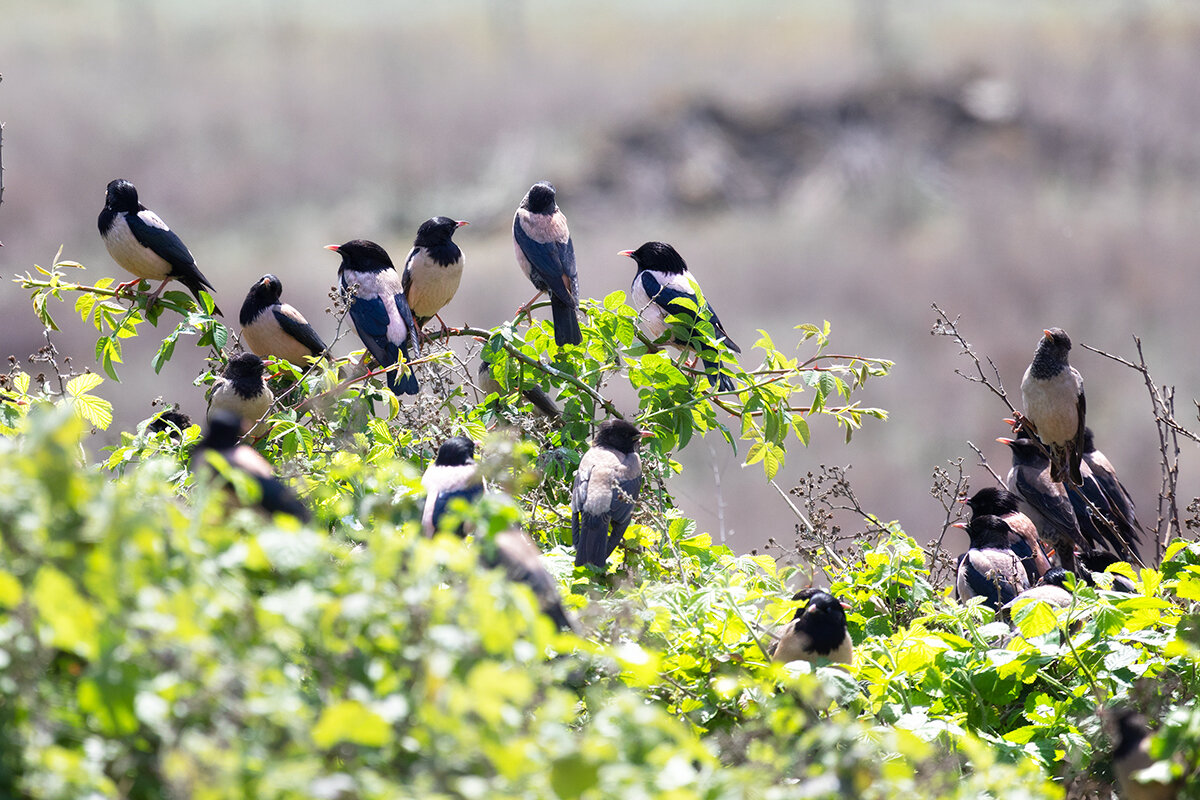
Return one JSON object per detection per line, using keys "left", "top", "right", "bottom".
{"left": 0, "top": 0, "right": 1200, "bottom": 551}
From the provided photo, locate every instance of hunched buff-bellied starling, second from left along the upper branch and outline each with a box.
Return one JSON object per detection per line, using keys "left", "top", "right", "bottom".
{"left": 239, "top": 275, "right": 329, "bottom": 369}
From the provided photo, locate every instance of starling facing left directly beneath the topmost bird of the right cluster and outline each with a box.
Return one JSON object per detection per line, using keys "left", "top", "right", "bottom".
{"left": 996, "top": 437, "right": 1090, "bottom": 570}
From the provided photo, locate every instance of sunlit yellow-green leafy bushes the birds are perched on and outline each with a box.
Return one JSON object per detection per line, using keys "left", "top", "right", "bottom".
{"left": 0, "top": 265, "right": 1200, "bottom": 799}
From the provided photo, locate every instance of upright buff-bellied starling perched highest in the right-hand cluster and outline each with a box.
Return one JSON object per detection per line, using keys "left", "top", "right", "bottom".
{"left": 1021, "top": 327, "right": 1087, "bottom": 485}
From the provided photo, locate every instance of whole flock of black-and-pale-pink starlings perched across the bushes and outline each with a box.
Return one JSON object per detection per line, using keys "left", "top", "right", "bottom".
{"left": 98, "top": 180, "right": 1171, "bottom": 796}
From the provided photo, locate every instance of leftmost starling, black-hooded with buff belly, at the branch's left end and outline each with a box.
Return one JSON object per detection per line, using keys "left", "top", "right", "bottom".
{"left": 96, "top": 179, "right": 221, "bottom": 314}
